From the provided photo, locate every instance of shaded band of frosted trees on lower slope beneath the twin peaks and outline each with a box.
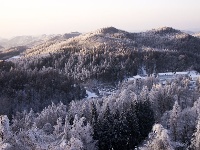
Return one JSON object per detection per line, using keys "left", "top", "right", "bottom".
{"left": 14, "top": 45, "right": 200, "bottom": 82}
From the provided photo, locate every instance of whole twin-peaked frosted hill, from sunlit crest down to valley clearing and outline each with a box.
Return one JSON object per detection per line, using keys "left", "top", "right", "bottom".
{"left": 14, "top": 27, "right": 200, "bottom": 80}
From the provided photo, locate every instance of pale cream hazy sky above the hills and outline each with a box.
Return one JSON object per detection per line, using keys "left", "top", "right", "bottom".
{"left": 0, "top": 0, "right": 200, "bottom": 38}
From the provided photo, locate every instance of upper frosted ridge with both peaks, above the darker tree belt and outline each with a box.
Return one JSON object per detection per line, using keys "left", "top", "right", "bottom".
{"left": 20, "top": 27, "right": 200, "bottom": 59}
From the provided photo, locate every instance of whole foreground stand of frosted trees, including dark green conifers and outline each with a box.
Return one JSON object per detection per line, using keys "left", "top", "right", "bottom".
{"left": 0, "top": 77, "right": 200, "bottom": 150}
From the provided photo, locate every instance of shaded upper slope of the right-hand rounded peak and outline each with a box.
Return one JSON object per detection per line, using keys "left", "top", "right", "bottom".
{"left": 135, "top": 27, "right": 200, "bottom": 54}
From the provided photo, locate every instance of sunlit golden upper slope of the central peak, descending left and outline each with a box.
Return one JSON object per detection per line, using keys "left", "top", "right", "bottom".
{"left": 20, "top": 27, "right": 134, "bottom": 57}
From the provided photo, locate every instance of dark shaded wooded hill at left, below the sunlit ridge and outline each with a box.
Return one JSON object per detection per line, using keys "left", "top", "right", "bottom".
{"left": 0, "top": 62, "right": 86, "bottom": 116}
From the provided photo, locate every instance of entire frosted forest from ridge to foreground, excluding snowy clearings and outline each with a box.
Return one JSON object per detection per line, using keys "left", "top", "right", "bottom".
{"left": 0, "top": 27, "right": 200, "bottom": 150}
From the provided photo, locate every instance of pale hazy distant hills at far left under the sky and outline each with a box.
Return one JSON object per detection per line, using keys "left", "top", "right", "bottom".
{"left": 0, "top": 32, "right": 80, "bottom": 60}
